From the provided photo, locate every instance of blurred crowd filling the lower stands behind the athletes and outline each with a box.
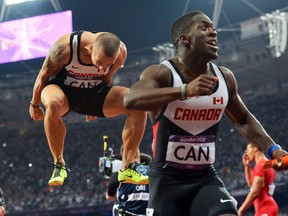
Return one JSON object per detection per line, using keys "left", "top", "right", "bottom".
{"left": 0, "top": 97, "right": 288, "bottom": 213}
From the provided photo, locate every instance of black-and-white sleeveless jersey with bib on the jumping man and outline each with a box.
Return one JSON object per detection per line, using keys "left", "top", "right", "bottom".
{"left": 56, "top": 32, "right": 112, "bottom": 88}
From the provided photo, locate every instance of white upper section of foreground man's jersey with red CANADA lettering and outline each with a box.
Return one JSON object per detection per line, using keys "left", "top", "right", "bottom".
{"left": 162, "top": 61, "right": 228, "bottom": 135}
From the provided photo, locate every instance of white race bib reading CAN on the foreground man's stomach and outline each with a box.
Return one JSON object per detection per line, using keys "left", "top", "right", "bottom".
{"left": 166, "top": 135, "right": 215, "bottom": 169}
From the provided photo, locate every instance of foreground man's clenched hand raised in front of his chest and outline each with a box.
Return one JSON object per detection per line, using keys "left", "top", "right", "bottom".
{"left": 186, "top": 74, "right": 218, "bottom": 97}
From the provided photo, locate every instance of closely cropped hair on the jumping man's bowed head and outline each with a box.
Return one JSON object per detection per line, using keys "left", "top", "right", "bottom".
{"left": 94, "top": 32, "right": 120, "bottom": 57}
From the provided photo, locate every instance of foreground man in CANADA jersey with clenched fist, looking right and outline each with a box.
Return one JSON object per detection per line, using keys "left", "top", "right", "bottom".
{"left": 124, "top": 11, "right": 287, "bottom": 216}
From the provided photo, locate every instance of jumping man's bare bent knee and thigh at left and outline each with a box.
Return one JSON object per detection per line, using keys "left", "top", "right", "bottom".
{"left": 41, "top": 84, "right": 69, "bottom": 116}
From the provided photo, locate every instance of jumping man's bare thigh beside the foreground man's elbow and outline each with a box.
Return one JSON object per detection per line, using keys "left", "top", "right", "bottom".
{"left": 103, "top": 86, "right": 129, "bottom": 117}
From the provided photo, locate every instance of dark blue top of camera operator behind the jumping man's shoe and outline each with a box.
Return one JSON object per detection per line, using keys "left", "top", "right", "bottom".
{"left": 117, "top": 163, "right": 149, "bottom": 216}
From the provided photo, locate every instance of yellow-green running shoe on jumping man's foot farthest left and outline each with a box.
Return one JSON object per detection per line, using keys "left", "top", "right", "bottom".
{"left": 48, "top": 162, "right": 70, "bottom": 186}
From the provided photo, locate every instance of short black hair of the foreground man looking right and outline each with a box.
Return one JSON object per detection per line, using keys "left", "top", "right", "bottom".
{"left": 171, "top": 11, "right": 204, "bottom": 48}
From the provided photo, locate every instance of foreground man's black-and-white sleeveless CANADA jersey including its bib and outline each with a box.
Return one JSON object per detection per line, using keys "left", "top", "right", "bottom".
{"left": 152, "top": 61, "right": 228, "bottom": 169}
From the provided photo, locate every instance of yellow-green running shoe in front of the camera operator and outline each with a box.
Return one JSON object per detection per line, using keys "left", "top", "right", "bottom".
{"left": 118, "top": 163, "right": 149, "bottom": 184}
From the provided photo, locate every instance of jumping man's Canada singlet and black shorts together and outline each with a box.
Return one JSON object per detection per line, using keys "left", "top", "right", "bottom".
{"left": 49, "top": 32, "right": 113, "bottom": 117}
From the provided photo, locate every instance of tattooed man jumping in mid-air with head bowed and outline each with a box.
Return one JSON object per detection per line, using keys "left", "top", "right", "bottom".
{"left": 29, "top": 31, "right": 148, "bottom": 186}
